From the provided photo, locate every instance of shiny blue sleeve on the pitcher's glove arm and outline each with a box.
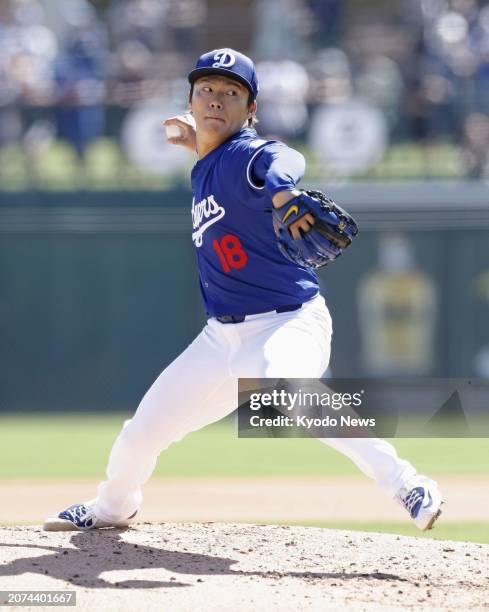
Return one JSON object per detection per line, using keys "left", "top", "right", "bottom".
{"left": 246, "top": 142, "right": 306, "bottom": 198}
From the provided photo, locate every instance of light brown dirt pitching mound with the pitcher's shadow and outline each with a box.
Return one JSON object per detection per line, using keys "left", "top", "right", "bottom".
{"left": 0, "top": 523, "right": 489, "bottom": 612}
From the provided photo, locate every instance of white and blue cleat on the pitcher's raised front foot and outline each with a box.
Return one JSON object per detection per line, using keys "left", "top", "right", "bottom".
{"left": 396, "top": 476, "right": 443, "bottom": 531}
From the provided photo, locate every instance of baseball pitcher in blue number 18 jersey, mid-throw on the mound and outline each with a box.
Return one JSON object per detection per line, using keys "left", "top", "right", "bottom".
{"left": 45, "top": 49, "right": 442, "bottom": 530}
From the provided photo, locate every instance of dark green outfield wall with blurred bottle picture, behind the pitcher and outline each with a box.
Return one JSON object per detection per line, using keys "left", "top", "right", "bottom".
{"left": 0, "top": 182, "right": 489, "bottom": 411}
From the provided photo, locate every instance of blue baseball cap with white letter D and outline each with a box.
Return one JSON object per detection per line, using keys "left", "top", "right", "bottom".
{"left": 188, "top": 49, "right": 258, "bottom": 99}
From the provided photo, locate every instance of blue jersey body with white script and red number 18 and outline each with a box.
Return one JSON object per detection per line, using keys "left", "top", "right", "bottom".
{"left": 192, "top": 128, "right": 318, "bottom": 317}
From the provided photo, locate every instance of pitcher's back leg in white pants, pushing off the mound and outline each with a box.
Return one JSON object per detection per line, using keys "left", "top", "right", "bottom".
{"left": 94, "top": 330, "right": 237, "bottom": 521}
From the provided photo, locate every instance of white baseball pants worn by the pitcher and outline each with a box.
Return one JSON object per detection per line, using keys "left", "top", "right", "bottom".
{"left": 94, "top": 295, "right": 416, "bottom": 521}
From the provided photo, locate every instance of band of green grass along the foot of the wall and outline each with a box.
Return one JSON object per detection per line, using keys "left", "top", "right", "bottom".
{"left": 0, "top": 414, "right": 489, "bottom": 478}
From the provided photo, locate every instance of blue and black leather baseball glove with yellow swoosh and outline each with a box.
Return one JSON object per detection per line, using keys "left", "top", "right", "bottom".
{"left": 272, "top": 190, "right": 358, "bottom": 268}
